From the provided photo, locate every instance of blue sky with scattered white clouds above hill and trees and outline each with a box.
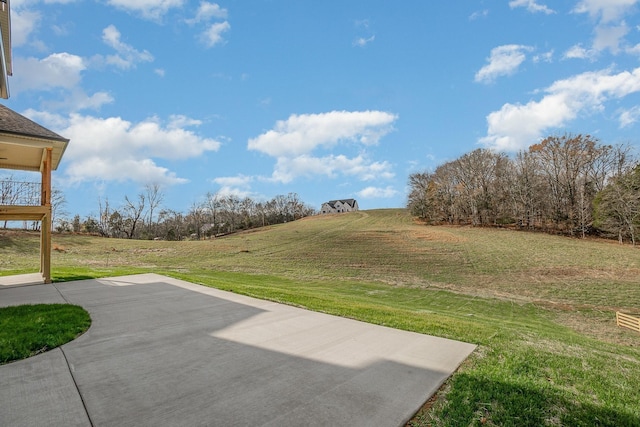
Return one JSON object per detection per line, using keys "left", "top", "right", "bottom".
{"left": 3, "top": 0, "right": 640, "bottom": 217}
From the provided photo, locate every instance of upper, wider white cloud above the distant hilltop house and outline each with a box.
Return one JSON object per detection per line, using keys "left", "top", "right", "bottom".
{"left": 248, "top": 111, "right": 398, "bottom": 157}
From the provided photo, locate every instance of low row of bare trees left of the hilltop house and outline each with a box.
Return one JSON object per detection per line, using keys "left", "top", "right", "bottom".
{"left": 57, "top": 185, "right": 315, "bottom": 240}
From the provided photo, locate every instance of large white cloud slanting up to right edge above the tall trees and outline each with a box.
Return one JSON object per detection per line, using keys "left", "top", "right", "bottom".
{"left": 480, "top": 68, "right": 640, "bottom": 151}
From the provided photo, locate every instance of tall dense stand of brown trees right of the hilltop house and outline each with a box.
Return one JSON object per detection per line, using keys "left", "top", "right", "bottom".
{"left": 408, "top": 134, "right": 640, "bottom": 241}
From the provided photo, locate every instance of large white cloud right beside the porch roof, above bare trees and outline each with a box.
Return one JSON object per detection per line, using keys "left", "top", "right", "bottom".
{"left": 21, "top": 111, "right": 220, "bottom": 184}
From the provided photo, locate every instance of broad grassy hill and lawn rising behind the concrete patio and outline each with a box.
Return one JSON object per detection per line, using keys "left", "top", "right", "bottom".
{"left": 0, "top": 209, "right": 640, "bottom": 426}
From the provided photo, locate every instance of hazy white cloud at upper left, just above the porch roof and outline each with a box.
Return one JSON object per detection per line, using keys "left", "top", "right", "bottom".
{"left": 11, "top": 52, "right": 86, "bottom": 93}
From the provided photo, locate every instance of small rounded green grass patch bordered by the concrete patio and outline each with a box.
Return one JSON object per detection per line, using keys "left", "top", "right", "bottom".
{"left": 0, "top": 304, "right": 91, "bottom": 364}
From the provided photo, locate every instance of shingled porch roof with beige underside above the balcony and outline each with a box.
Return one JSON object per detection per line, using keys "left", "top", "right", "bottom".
{"left": 0, "top": 105, "right": 69, "bottom": 171}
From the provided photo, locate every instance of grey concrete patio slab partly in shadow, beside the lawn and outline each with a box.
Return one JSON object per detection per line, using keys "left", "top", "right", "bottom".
{"left": 0, "top": 274, "right": 475, "bottom": 426}
